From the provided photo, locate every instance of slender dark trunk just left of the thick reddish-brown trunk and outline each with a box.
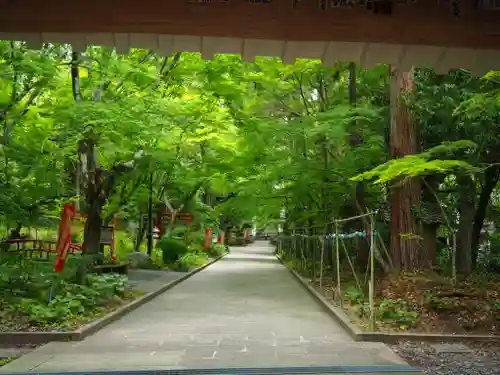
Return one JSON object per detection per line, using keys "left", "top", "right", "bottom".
{"left": 349, "top": 63, "right": 370, "bottom": 267}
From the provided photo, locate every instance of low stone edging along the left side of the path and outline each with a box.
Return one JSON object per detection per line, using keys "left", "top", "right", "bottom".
{"left": 0, "top": 254, "right": 226, "bottom": 345}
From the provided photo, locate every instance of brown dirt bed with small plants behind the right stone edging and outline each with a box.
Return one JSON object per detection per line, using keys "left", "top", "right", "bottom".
{"left": 313, "top": 273, "right": 500, "bottom": 335}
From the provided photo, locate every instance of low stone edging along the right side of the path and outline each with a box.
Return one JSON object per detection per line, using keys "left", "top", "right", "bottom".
{"left": 276, "top": 255, "right": 500, "bottom": 343}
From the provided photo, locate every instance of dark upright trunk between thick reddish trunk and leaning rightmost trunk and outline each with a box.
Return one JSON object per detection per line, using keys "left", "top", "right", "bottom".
{"left": 455, "top": 175, "right": 476, "bottom": 276}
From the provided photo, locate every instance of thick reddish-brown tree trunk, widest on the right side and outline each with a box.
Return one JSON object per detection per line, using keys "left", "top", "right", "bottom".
{"left": 389, "top": 67, "right": 422, "bottom": 271}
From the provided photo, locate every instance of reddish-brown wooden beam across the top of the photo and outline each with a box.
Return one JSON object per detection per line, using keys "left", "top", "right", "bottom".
{"left": 0, "top": 0, "right": 500, "bottom": 50}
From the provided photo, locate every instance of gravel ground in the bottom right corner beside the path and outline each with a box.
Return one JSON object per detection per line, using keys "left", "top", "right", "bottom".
{"left": 392, "top": 342, "right": 500, "bottom": 375}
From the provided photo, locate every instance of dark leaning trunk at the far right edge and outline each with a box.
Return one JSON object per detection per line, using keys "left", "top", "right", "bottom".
{"left": 471, "top": 166, "right": 500, "bottom": 268}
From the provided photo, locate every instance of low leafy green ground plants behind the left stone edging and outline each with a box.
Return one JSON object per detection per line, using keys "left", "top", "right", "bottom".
{"left": 0, "top": 258, "right": 132, "bottom": 330}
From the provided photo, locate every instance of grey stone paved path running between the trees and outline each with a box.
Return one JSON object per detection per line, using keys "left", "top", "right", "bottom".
{"left": 0, "top": 242, "right": 414, "bottom": 373}
